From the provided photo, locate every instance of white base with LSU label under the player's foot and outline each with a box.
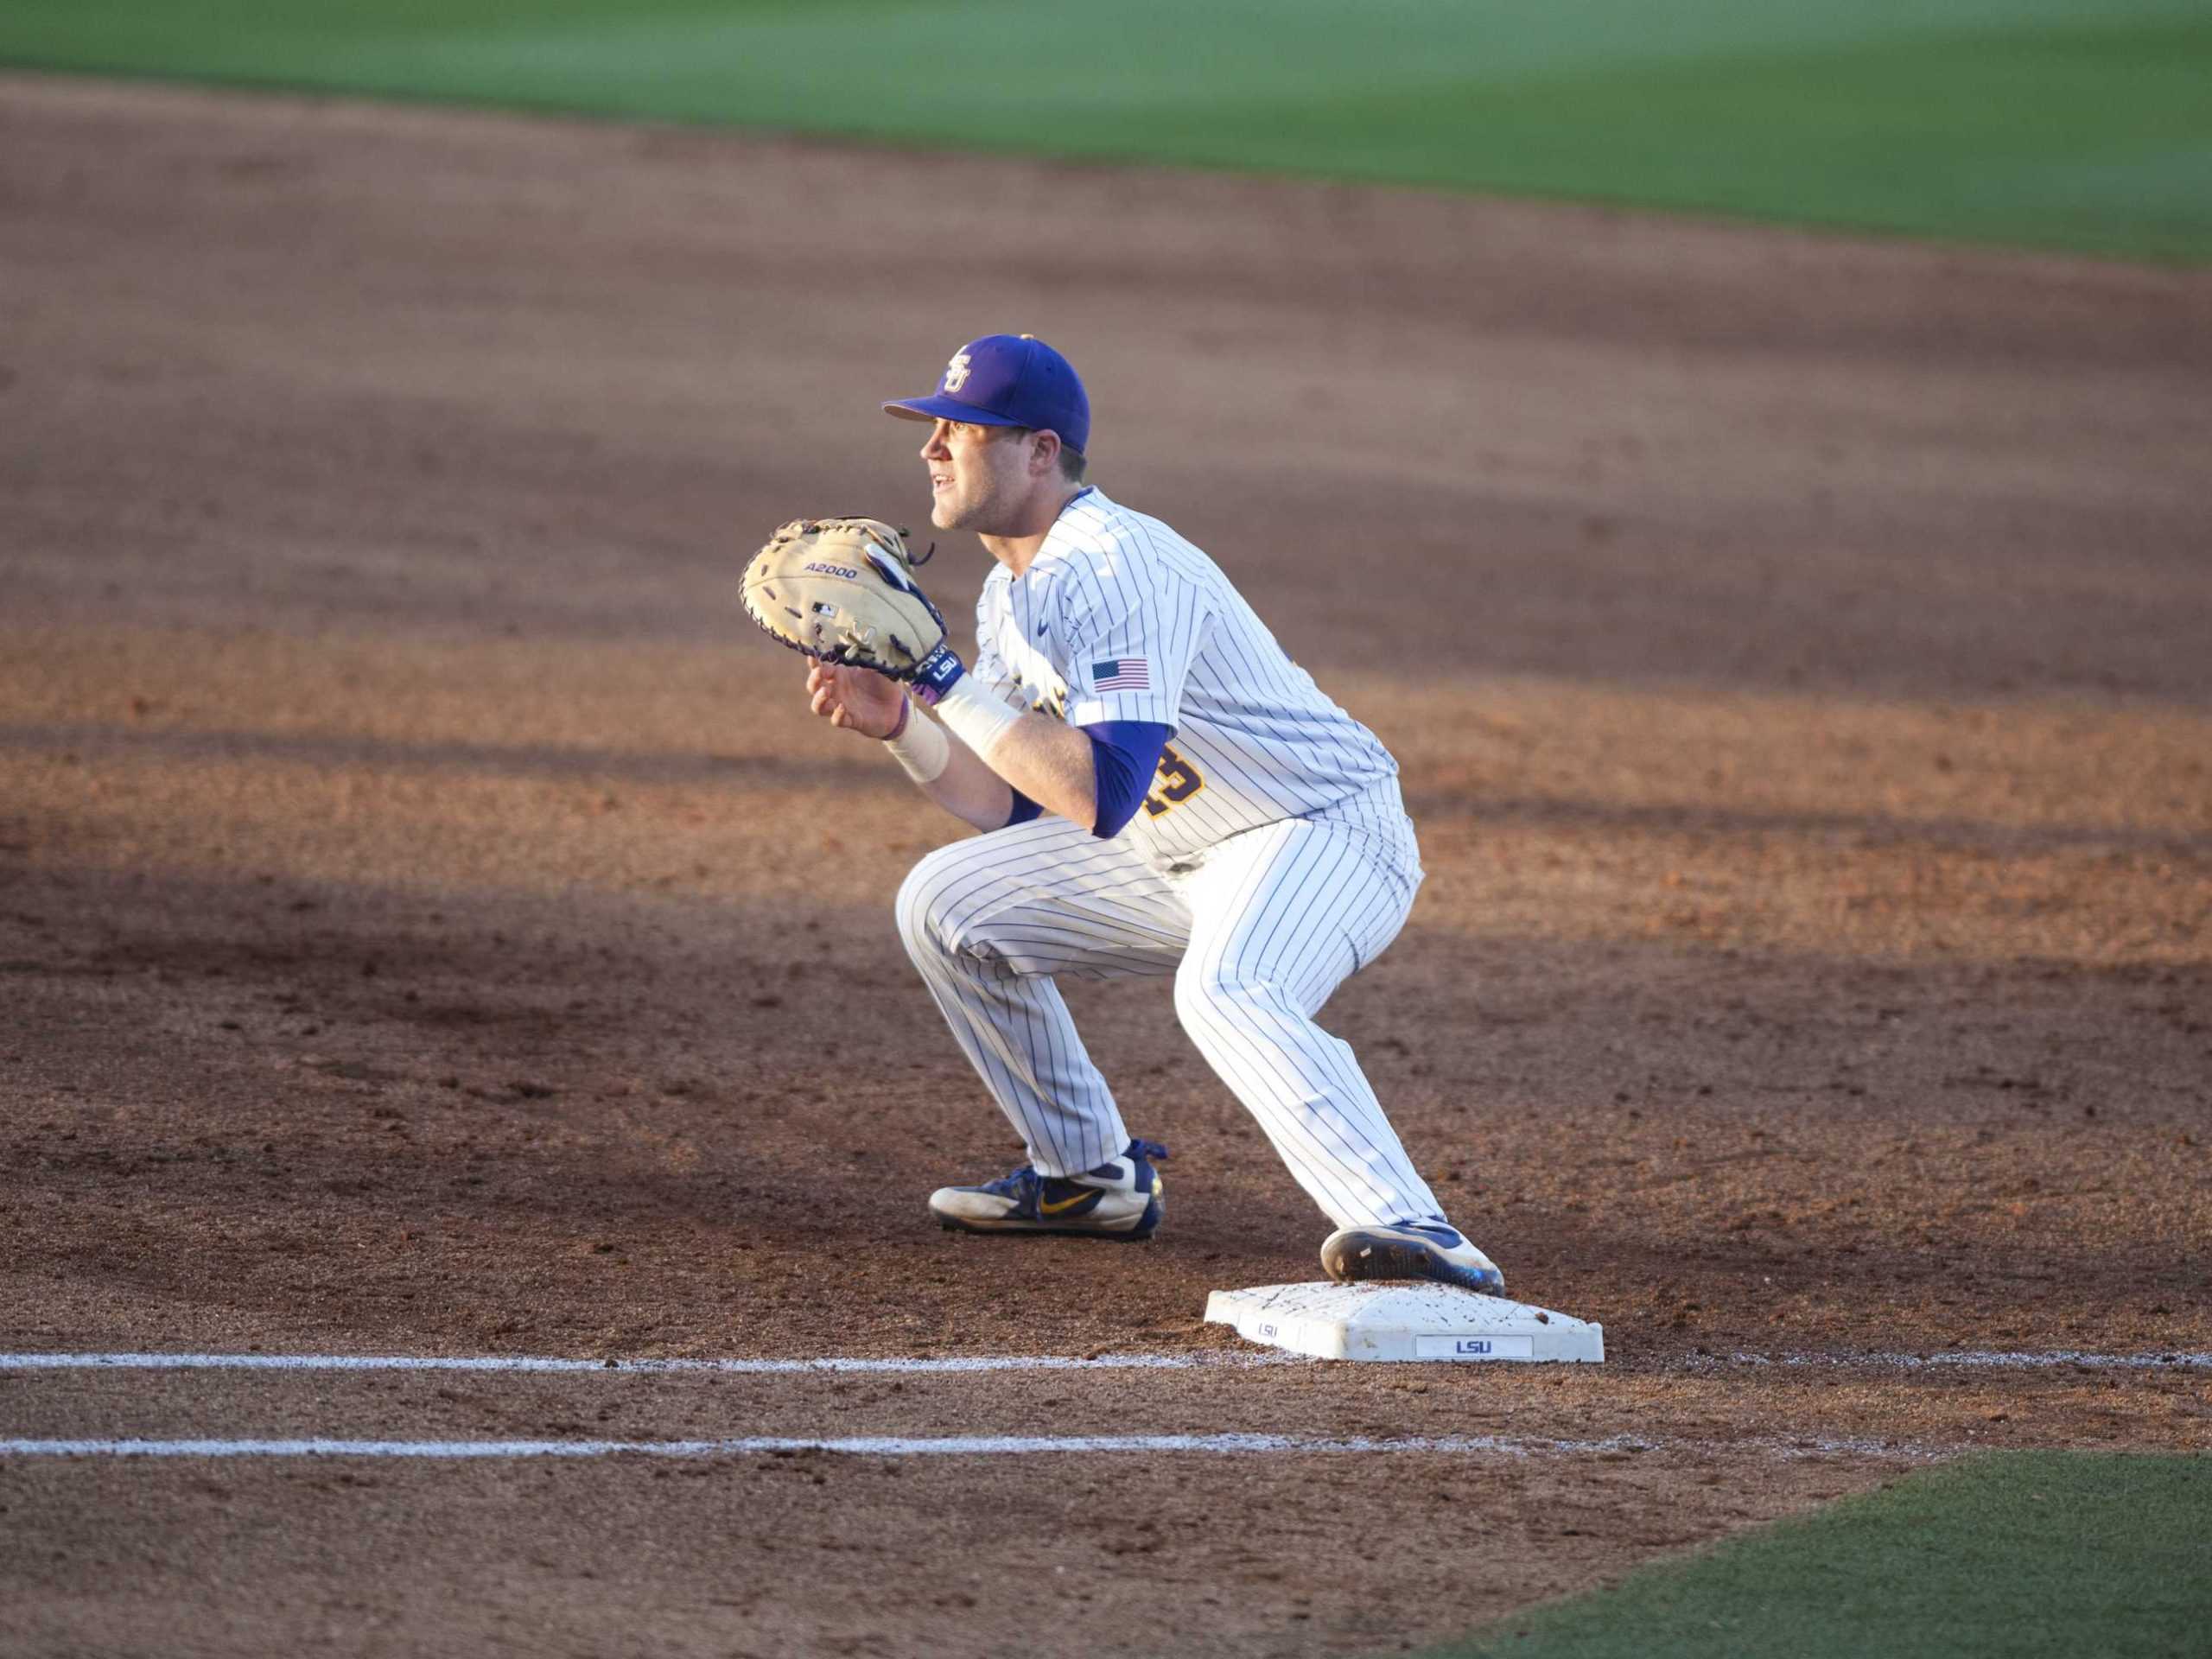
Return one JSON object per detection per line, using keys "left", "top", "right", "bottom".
{"left": 1205, "top": 1281, "right": 1606, "bottom": 1365}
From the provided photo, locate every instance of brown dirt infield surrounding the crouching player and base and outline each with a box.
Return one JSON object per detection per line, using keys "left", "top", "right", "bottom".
{"left": 0, "top": 79, "right": 2212, "bottom": 1655}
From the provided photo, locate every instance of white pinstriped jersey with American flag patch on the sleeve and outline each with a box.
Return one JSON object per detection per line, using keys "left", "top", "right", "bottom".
{"left": 976, "top": 489, "right": 1398, "bottom": 868}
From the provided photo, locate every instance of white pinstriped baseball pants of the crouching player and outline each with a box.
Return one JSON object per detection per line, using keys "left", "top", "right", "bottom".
{"left": 898, "top": 785, "right": 1442, "bottom": 1228}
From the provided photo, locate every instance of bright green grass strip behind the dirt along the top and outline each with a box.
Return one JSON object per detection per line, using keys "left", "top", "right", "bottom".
{"left": 0, "top": 0, "right": 2212, "bottom": 261}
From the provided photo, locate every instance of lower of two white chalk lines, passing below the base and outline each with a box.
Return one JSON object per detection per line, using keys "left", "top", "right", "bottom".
{"left": 0, "top": 1433, "right": 1924, "bottom": 1460}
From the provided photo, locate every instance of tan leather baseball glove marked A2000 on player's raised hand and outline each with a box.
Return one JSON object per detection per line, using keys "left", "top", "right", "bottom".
{"left": 743, "top": 518, "right": 944, "bottom": 679}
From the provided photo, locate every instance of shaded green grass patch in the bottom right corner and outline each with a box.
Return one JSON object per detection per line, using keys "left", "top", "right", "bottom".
{"left": 1429, "top": 1451, "right": 2212, "bottom": 1659}
